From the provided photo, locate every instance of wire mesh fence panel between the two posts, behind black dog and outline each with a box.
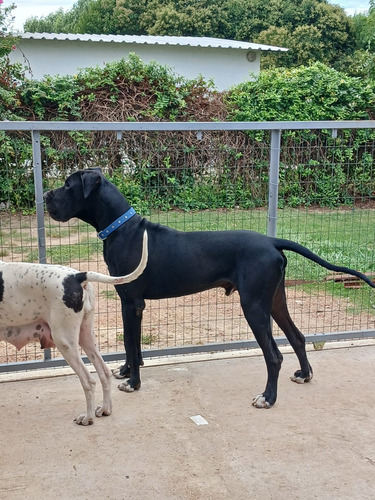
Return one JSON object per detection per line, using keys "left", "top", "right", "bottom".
{"left": 44, "top": 132, "right": 269, "bottom": 353}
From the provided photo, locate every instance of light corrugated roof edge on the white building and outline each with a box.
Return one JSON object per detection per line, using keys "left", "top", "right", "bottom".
{"left": 18, "top": 32, "right": 288, "bottom": 52}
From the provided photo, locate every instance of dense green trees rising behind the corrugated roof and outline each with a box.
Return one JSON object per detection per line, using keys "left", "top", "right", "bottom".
{"left": 25, "top": 0, "right": 355, "bottom": 70}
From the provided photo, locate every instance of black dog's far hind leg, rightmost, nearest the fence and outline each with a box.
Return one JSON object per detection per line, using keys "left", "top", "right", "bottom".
{"left": 271, "top": 279, "right": 313, "bottom": 384}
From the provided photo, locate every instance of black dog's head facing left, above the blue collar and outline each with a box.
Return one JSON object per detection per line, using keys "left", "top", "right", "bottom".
{"left": 44, "top": 168, "right": 105, "bottom": 222}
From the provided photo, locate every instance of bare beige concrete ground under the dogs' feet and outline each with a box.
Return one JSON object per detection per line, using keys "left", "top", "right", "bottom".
{"left": 0, "top": 344, "right": 375, "bottom": 500}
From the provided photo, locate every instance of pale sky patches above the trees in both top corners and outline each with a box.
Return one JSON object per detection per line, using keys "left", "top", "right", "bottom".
{"left": 2, "top": 0, "right": 369, "bottom": 31}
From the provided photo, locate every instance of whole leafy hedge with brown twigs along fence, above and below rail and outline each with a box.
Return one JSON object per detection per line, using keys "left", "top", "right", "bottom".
{"left": 0, "top": 55, "right": 375, "bottom": 211}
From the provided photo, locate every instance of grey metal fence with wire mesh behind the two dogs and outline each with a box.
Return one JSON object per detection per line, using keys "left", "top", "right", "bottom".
{"left": 0, "top": 121, "right": 375, "bottom": 371}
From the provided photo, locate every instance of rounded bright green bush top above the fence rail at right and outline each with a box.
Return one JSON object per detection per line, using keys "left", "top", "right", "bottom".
{"left": 227, "top": 63, "right": 375, "bottom": 121}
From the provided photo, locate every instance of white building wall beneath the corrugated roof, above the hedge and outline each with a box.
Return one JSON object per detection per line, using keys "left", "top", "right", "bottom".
{"left": 10, "top": 39, "right": 261, "bottom": 91}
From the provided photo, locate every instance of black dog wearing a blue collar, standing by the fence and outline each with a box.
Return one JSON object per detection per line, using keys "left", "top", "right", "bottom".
{"left": 45, "top": 169, "right": 375, "bottom": 408}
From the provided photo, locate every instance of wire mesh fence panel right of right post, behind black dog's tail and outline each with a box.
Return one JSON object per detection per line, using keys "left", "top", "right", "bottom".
{"left": 276, "top": 130, "right": 375, "bottom": 334}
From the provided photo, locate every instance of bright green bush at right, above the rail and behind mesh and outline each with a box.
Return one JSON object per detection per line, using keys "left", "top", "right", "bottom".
{"left": 226, "top": 63, "right": 375, "bottom": 206}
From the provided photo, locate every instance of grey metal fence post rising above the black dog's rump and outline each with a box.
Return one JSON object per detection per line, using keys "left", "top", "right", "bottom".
{"left": 267, "top": 130, "right": 281, "bottom": 237}
